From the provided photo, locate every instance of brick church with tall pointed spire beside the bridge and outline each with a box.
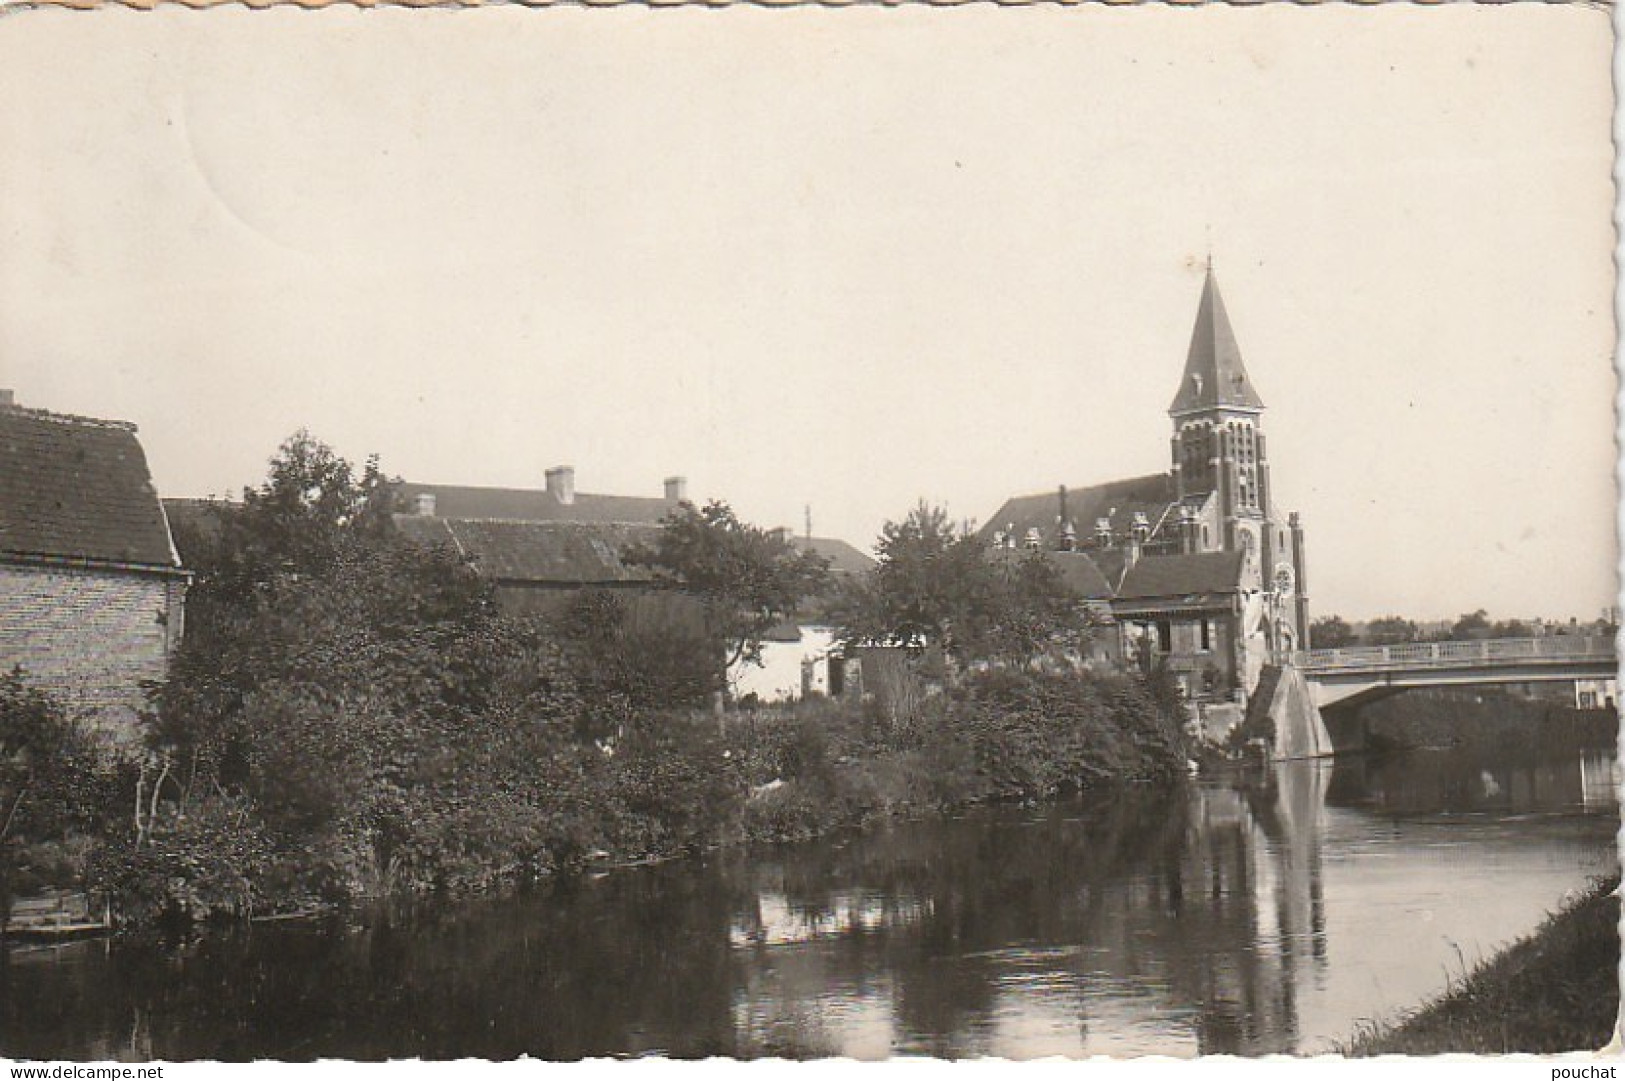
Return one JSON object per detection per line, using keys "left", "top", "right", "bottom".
{"left": 982, "top": 263, "right": 1310, "bottom": 707}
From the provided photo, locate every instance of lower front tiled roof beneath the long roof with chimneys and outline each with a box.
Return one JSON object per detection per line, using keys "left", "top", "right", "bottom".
{"left": 395, "top": 514, "right": 657, "bottom": 585}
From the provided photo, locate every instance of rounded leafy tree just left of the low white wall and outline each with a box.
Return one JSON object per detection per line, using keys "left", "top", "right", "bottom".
{"left": 624, "top": 501, "right": 830, "bottom": 676}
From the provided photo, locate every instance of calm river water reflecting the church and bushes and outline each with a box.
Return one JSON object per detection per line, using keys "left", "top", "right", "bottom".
{"left": 0, "top": 741, "right": 1617, "bottom": 1060}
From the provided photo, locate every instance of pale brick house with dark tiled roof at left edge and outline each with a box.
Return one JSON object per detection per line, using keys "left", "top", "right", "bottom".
{"left": 0, "top": 392, "right": 189, "bottom": 740}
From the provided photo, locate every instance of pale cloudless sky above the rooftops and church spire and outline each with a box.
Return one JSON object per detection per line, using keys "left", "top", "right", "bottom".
{"left": 0, "top": 5, "right": 1615, "bottom": 618}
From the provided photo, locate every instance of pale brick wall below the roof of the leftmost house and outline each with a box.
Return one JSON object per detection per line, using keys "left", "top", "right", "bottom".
{"left": 0, "top": 566, "right": 184, "bottom": 740}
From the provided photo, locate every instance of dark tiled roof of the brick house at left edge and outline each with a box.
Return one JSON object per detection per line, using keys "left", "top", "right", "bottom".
{"left": 0, "top": 406, "right": 179, "bottom": 569}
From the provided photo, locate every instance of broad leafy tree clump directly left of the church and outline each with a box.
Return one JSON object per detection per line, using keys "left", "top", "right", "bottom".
{"left": 834, "top": 502, "right": 1094, "bottom": 663}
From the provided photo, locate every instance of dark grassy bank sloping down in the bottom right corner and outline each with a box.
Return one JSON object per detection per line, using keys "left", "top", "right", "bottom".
{"left": 1346, "top": 875, "right": 1620, "bottom": 1055}
